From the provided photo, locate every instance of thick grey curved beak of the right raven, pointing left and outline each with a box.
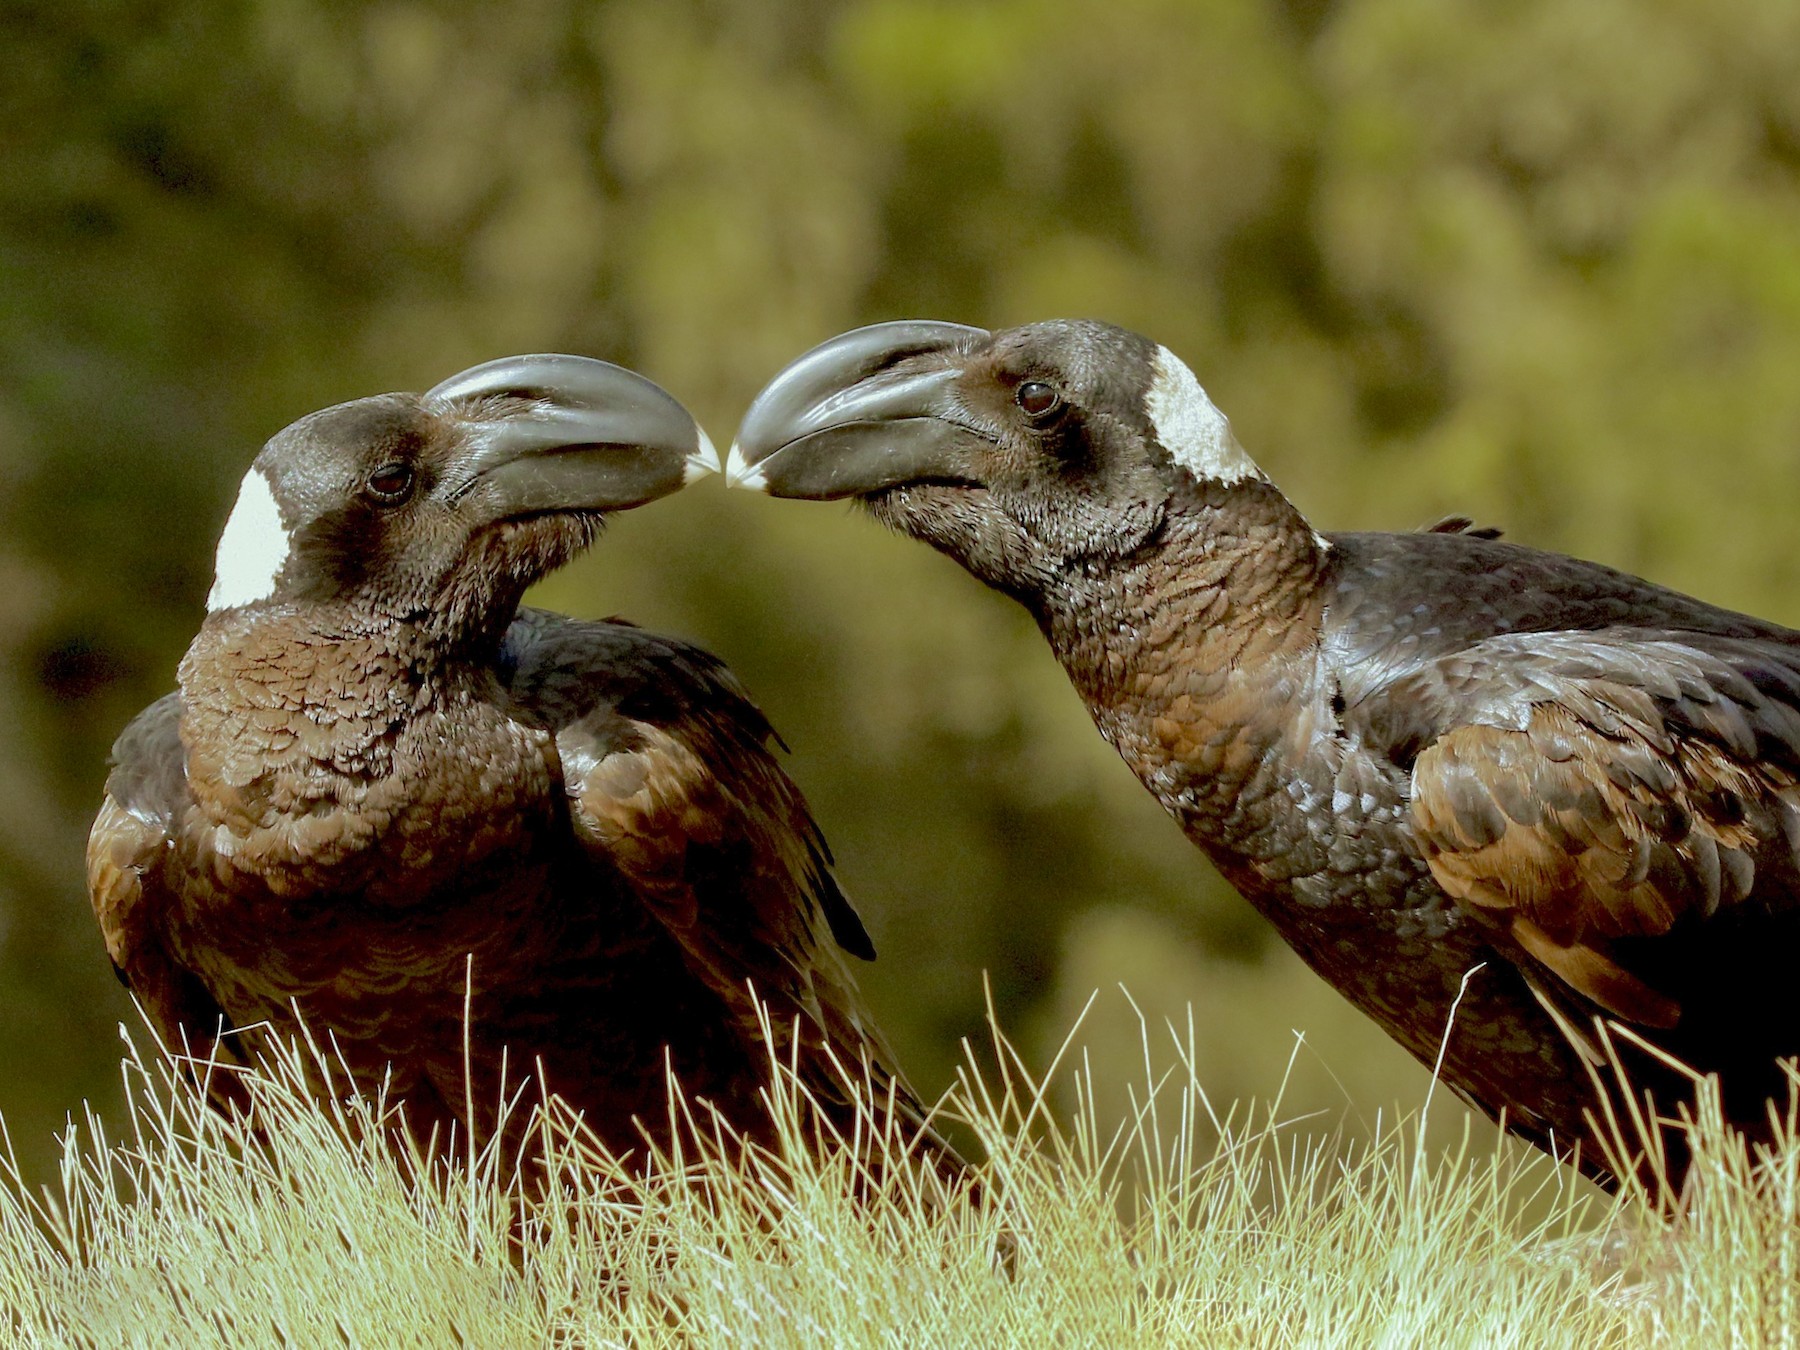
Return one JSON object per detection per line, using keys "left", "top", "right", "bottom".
{"left": 725, "top": 320, "right": 990, "bottom": 500}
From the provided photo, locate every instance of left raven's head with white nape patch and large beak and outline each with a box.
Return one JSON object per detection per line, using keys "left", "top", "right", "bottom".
{"left": 207, "top": 356, "right": 716, "bottom": 641}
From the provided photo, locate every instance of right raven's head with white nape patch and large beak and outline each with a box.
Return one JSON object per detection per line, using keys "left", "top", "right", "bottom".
{"left": 727, "top": 320, "right": 1264, "bottom": 596}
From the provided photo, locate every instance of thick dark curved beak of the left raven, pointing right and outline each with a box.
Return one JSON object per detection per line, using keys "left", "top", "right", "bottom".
{"left": 425, "top": 355, "right": 718, "bottom": 520}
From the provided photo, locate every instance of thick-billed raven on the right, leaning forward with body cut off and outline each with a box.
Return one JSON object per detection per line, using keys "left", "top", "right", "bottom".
{"left": 727, "top": 320, "right": 1800, "bottom": 1186}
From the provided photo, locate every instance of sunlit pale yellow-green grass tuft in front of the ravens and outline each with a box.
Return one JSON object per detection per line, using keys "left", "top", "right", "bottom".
{"left": 0, "top": 1008, "right": 1800, "bottom": 1346}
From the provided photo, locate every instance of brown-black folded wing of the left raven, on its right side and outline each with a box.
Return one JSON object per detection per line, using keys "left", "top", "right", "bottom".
{"left": 508, "top": 612, "right": 923, "bottom": 1121}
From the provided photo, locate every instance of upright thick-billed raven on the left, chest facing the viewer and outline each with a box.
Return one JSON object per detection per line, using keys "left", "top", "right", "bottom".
{"left": 88, "top": 355, "right": 952, "bottom": 1161}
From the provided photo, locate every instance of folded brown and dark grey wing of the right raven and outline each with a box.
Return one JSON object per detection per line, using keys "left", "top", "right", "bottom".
{"left": 1396, "top": 634, "right": 1800, "bottom": 1028}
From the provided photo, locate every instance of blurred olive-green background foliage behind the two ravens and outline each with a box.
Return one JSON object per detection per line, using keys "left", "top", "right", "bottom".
{"left": 10, "top": 0, "right": 1800, "bottom": 1175}
